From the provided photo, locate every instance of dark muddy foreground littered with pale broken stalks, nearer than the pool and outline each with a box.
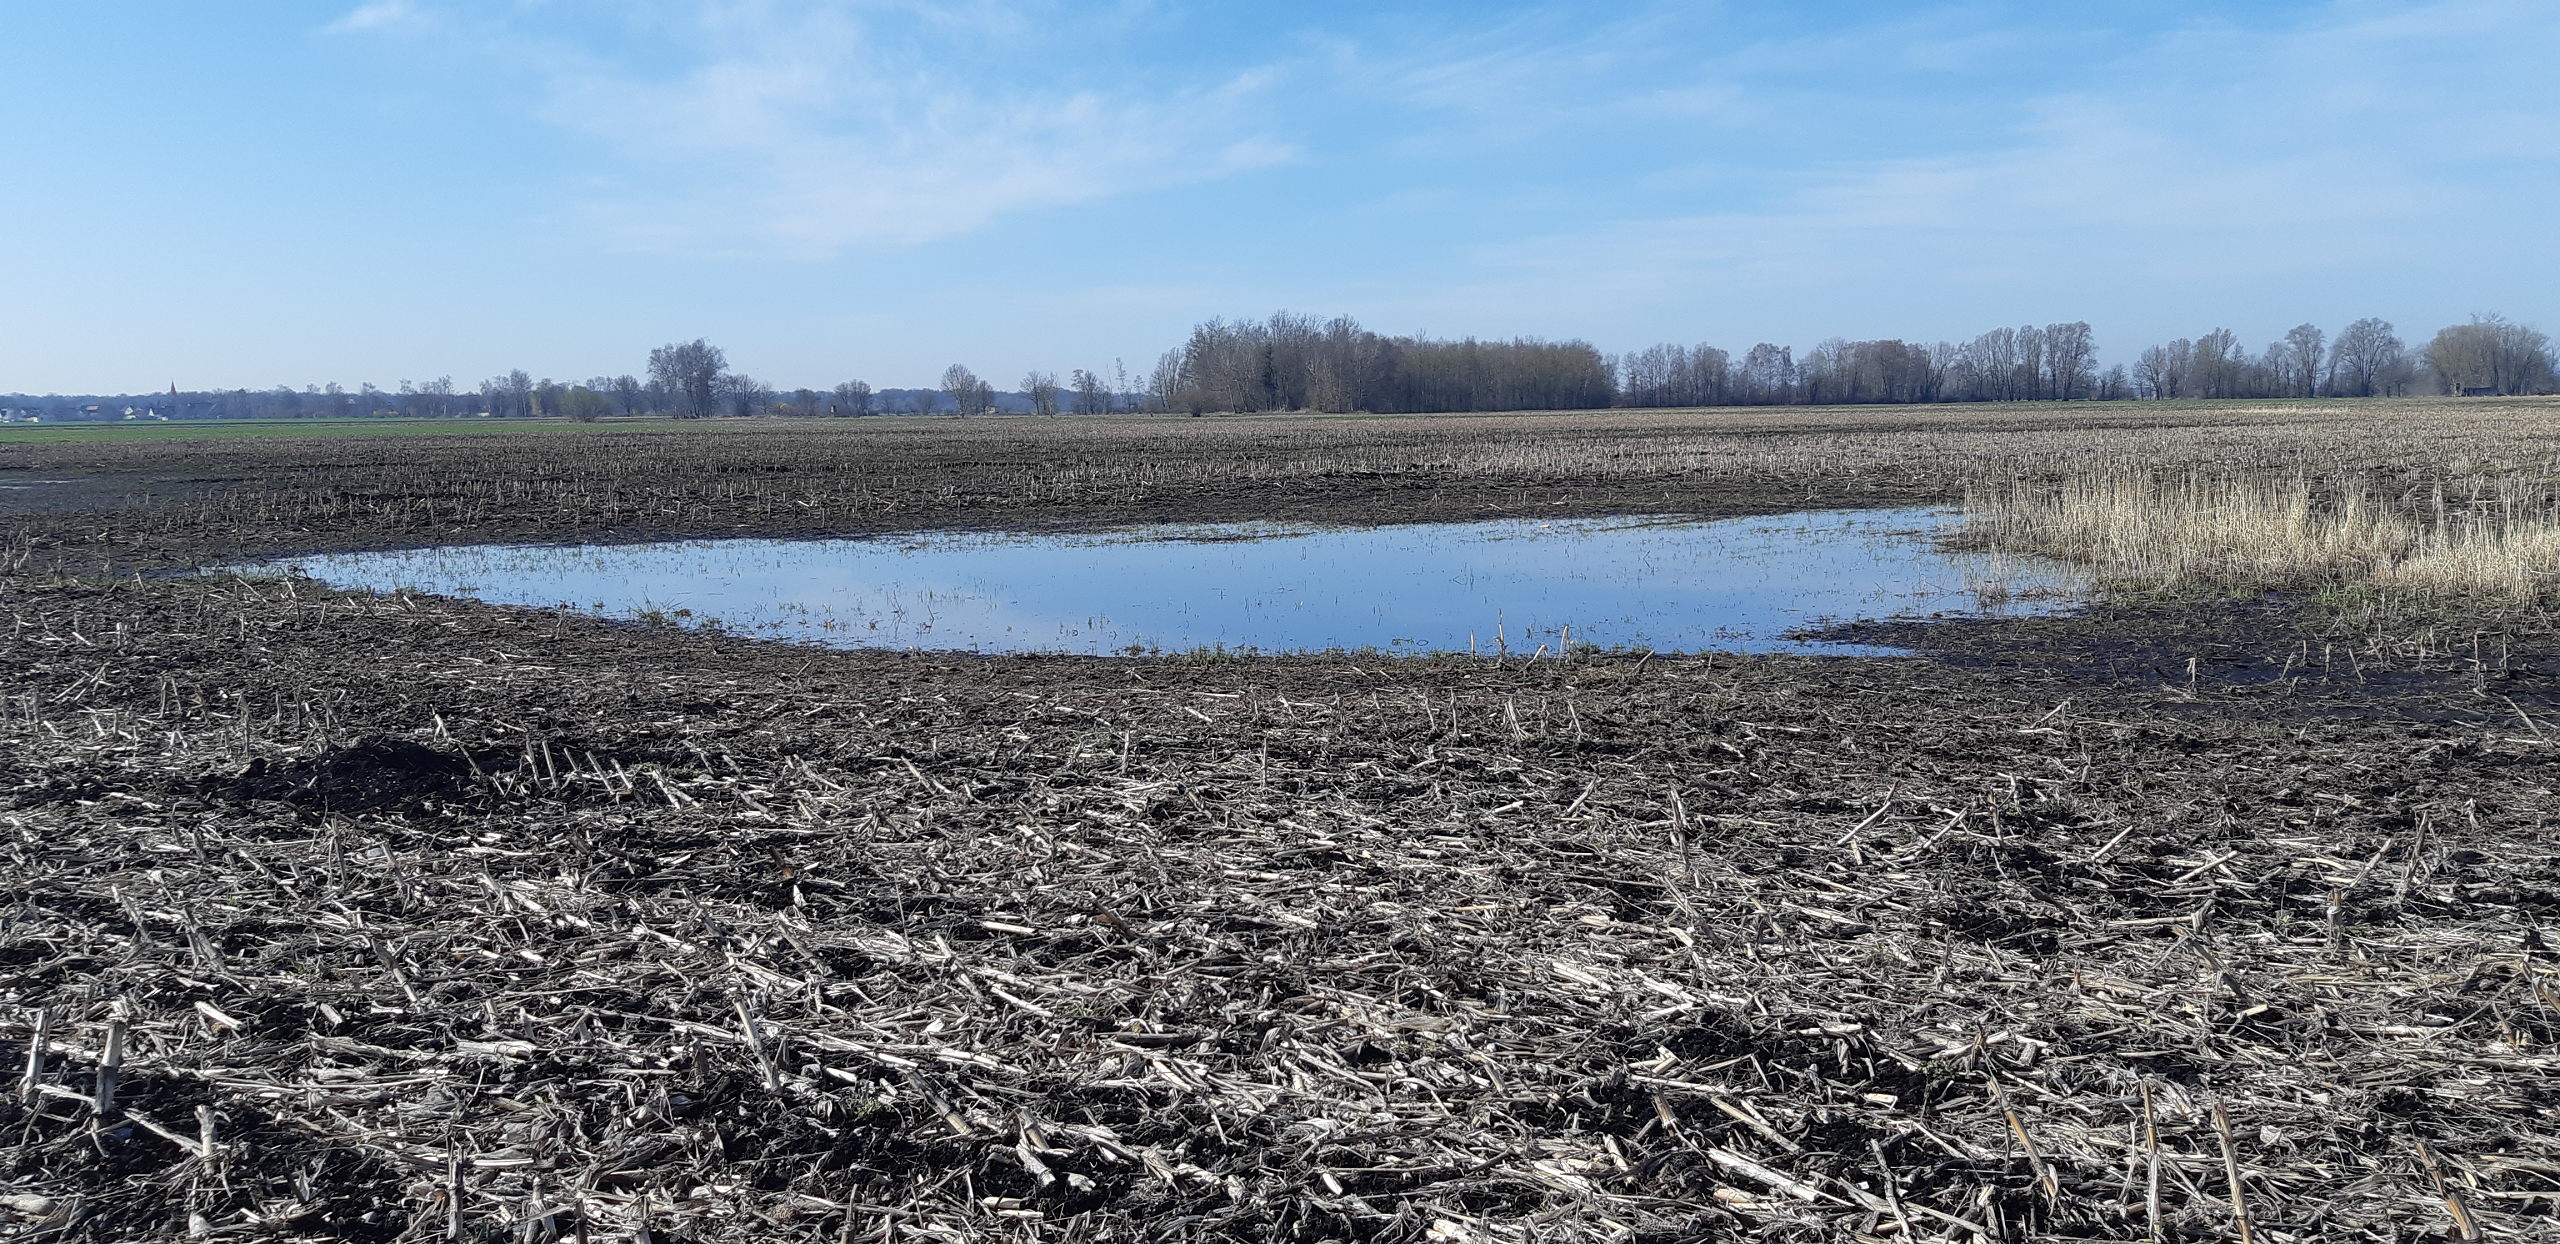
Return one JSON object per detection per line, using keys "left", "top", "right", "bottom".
{"left": 0, "top": 412, "right": 2560, "bottom": 1241}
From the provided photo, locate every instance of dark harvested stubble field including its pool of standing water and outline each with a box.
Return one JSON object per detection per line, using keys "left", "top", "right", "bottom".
{"left": 15, "top": 399, "right": 2560, "bottom": 1244}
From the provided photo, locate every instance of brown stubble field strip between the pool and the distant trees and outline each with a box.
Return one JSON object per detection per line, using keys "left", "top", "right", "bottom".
{"left": 20, "top": 399, "right": 2552, "bottom": 568}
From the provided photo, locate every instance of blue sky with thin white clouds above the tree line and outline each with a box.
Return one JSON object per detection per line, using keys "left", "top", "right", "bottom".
{"left": 0, "top": 0, "right": 2560, "bottom": 392}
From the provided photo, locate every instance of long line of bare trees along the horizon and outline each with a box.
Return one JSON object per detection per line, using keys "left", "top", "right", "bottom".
{"left": 0, "top": 312, "right": 2560, "bottom": 422}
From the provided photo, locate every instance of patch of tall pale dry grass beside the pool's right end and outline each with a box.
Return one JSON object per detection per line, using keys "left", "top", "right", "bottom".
{"left": 1964, "top": 468, "right": 2560, "bottom": 602}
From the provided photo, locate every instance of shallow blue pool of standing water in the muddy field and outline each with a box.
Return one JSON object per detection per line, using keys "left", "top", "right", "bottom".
{"left": 240, "top": 509, "right": 2081, "bottom": 655}
